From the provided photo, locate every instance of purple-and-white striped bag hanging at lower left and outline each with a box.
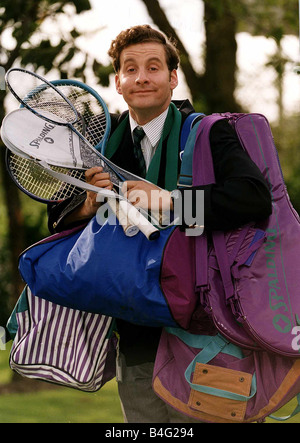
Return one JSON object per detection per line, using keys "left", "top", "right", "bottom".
{"left": 7, "top": 286, "right": 116, "bottom": 392}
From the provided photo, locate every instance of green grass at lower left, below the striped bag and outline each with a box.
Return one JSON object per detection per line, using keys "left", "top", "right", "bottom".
{"left": 0, "top": 350, "right": 123, "bottom": 423}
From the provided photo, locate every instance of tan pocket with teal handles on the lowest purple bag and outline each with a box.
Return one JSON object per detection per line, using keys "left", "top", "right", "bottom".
{"left": 166, "top": 328, "right": 257, "bottom": 422}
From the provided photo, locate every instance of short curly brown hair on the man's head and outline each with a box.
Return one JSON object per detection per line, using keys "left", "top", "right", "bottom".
{"left": 108, "top": 25, "right": 180, "bottom": 72}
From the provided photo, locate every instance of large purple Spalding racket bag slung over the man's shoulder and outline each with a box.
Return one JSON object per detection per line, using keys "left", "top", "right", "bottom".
{"left": 198, "top": 114, "right": 300, "bottom": 358}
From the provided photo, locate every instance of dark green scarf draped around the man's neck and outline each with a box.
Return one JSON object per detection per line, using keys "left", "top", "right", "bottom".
{"left": 105, "top": 103, "right": 182, "bottom": 191}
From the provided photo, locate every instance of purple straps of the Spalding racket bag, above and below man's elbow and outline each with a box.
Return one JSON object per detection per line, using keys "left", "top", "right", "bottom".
{"left": 193, "top": 115, "right": 234, "bottom": 300}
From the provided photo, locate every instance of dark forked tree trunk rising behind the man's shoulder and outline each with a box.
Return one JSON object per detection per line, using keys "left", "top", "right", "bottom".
{"left": 143, "top": 0, "right": 241, "bottom": 113}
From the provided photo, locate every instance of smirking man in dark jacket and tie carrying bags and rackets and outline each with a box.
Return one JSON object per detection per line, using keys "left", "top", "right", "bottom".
{"left": 49, "top": 25, "right": 271, "bottom": 423}
